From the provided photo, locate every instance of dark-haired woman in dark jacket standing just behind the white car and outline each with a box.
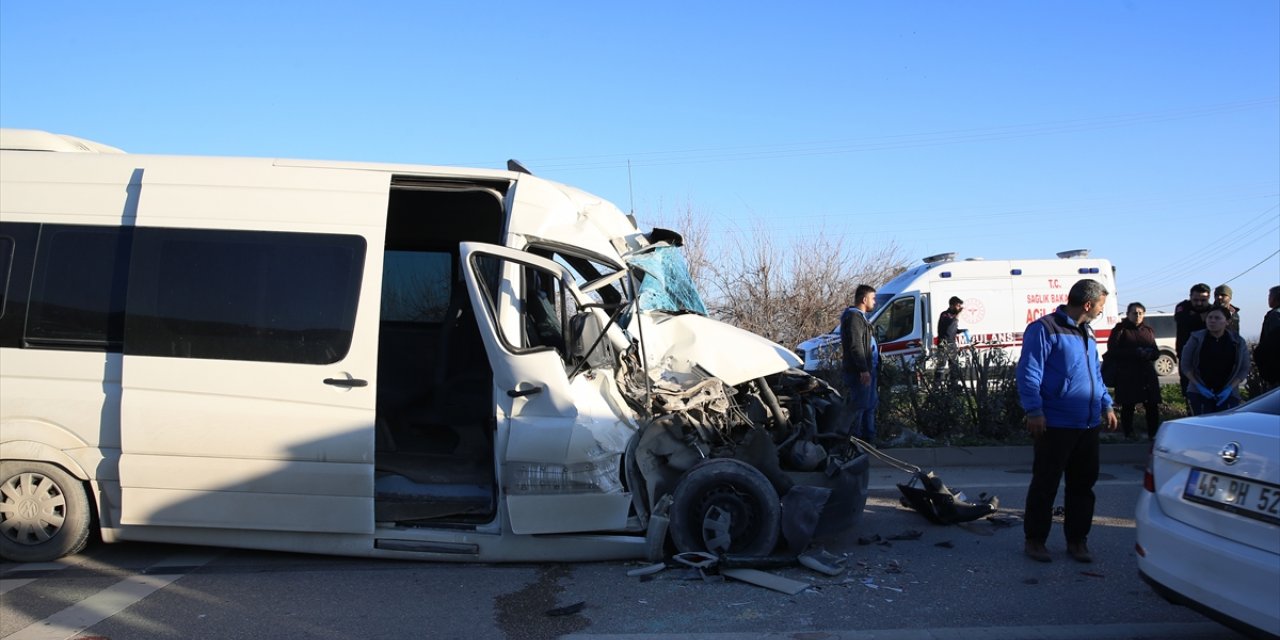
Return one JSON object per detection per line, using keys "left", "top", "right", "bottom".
{"left": 1178, "top": 305, "right": 1249, "bottom": 416}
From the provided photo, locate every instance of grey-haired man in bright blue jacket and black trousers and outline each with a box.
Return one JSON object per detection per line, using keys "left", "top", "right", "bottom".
{"left": 1018, "top": 279, "right": 1116, "bottom": 562}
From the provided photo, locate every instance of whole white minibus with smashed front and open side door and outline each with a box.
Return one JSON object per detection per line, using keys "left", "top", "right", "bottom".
{"left": 0, "top": 129, "right": 868, "bottom": 562}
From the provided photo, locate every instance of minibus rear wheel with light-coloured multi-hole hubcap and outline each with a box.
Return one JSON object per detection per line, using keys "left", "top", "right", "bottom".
{"left": 0, "top": 461, "right": 90, "bottom": 562}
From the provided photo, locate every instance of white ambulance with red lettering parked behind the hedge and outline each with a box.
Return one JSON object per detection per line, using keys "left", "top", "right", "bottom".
{"left": 796, "top": 250, "right": 1121, "bottom": 371}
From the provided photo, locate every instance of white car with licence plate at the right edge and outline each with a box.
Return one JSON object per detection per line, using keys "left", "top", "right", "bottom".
{"left": 1135, "top": 389, "right": 1280, "bottom": 637}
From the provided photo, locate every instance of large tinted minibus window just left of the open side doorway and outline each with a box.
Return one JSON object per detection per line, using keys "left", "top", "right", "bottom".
{"left": 124, "top": 228, "right": 366, "bottom": 365}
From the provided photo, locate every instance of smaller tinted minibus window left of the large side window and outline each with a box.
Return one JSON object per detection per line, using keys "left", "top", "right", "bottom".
{"left": 26, "top": 224, "right": 133, "bottom": 351}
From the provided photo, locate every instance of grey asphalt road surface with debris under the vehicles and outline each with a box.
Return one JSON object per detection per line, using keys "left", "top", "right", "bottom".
{"left": 0, "top": 463, "right": 1239, "bottom": 640}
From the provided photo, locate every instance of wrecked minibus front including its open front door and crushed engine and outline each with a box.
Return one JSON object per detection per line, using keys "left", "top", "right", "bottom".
{"left": 462, "top": 206, "right": 869, "bottom": 558}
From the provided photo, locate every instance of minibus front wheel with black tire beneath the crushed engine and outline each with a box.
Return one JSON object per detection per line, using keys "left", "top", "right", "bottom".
{"left": 669, "top": 458, "right": 782, "bottom": 556}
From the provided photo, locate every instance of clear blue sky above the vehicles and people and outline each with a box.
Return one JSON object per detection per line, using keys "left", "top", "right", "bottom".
{"left": 0, "top": 0, "right": 1280, "bottom": 337}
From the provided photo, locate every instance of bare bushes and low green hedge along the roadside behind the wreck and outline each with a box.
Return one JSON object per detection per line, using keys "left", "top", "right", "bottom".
{"left": 640, "top": 206, "right": 1265, "bottom": 447}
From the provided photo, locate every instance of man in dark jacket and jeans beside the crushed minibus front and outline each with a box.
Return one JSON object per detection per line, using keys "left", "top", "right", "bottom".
{"left": 840, "top": 284, "right": 879, "bottom": 444}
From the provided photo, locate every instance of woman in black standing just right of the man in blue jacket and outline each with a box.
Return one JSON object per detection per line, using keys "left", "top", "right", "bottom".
{"left": 1107, "top": 302, "right": 1160, "bottom": 440}
